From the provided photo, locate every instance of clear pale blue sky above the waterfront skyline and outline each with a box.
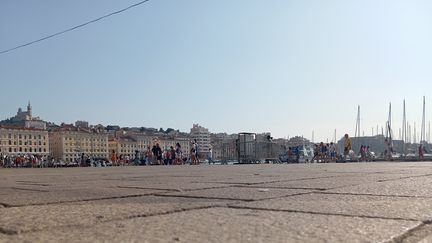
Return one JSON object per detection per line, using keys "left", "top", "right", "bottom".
{"left": 0, "top": 0, "right": 432, "bottom": 141}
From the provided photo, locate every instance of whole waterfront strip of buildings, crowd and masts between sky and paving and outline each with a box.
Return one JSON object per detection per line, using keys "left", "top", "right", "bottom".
{"left": 0, "top": 102, "right": 432, "bottom": 168}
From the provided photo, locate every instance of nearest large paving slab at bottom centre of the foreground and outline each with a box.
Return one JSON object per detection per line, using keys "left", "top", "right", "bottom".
{"left": 3, "top": 208, "right": 419, "bottom": 242}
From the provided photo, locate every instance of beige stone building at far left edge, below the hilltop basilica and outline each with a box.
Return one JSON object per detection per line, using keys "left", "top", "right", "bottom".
{"left": 0, "top": 126, "right": 49, "bottom": 156}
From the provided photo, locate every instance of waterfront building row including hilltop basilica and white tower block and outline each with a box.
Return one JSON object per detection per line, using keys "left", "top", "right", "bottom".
{"left": 0, "top": 102, "right": 211, "bottom": 161}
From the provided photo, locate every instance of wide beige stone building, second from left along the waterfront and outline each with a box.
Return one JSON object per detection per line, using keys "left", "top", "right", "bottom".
{"left": 49, "top": 125, "right": 109, "bottom": 161}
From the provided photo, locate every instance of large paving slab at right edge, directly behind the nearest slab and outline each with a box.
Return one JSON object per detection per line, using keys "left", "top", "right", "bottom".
{"left": 234, "top": 193, "right": 432, "bottom": 221}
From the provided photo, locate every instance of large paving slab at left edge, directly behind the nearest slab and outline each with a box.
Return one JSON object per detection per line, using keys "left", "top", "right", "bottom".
{"left": 0, "top": 196, "right": 232, "bottom": 233}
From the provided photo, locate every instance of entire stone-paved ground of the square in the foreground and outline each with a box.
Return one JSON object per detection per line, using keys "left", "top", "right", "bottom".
{"left": 0, "top": 162, "right": 432, "bottom": 242}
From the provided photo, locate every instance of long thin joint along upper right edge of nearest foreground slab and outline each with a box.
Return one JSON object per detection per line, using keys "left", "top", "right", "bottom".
{"left": 227, "top": 205, "right": 418, "bottom": 221}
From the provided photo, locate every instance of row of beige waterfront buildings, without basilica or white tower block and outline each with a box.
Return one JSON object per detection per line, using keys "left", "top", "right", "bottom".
{"left": 0, "top": 125, "right": 201, "bottom": 161}
